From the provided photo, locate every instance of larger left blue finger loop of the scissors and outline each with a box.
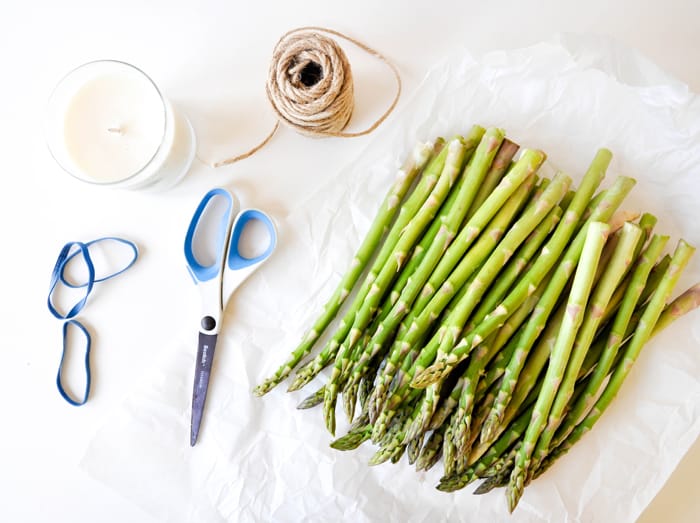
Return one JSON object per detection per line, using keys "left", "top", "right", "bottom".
{"left": 185, "top": 188, "right": 234, "bottom": 282}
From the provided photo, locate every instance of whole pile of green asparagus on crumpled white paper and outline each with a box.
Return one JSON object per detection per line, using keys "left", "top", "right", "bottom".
{"left": 255, "top": 126, "right": 700, "bottom": 511}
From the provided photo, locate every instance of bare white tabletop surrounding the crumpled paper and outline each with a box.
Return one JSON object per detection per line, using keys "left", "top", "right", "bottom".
{"left": 0, "top": 0, "right": 700, "bottom": 522}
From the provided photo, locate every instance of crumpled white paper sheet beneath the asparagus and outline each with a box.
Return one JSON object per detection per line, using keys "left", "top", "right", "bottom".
{"left": 82, "top": 36, "right": 700, "bottom": 522}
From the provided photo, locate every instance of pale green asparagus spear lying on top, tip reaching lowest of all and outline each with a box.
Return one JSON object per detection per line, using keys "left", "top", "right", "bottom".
{"left": 506, "top": 222, "right": 610, "bottom": 512}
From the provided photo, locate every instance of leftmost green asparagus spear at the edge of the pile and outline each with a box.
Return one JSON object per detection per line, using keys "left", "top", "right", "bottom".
{"left": 253, "top": 139, "right": 434, "bottom": 396}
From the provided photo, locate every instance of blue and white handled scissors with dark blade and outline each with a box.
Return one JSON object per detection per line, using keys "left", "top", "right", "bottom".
{"left": 185, "top": 188, "right": 277, "bottom": 446}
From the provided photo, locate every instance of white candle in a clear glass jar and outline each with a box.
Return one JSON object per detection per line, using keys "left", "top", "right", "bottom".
{"left": 47, "top": 60, "right": 195, "bottom": 189}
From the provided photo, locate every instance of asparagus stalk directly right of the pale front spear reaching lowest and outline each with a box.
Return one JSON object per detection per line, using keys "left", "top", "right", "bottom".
{"left": 532, "top": 223, "right": 642, "bottom": 470}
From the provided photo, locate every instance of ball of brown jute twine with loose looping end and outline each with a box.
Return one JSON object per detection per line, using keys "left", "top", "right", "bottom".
{"left": 214, "top": 27, "right": 401, "bottom": 167}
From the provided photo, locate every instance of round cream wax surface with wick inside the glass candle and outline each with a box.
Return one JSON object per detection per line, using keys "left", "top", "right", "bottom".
{"left": 64, "top": 72, "right": 166, "bottom": 182}
